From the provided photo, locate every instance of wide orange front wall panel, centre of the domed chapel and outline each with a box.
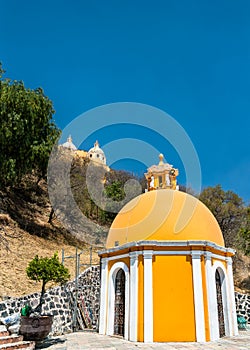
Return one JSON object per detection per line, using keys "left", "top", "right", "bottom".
{"left": 151, "top": 256, "right": 196, "bottom": 342}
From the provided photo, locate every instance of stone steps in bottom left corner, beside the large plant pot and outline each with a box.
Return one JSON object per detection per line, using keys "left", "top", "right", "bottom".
{"left": 0, "top": 326, "right": 35, "bottom": 350}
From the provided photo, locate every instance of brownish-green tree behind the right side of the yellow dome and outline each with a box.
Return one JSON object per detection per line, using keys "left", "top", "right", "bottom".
{"left": 199, "top": 185, "right": 246, "bottom": 247}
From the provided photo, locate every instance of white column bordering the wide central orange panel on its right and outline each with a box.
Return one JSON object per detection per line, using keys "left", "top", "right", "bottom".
{"left": 191, "top": 251, "right": 206, "bottom": 342}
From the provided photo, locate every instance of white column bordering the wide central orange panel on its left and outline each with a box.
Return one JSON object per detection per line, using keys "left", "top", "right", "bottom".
{"left": 143, "top": 250, "right": 153, "bottom": 343}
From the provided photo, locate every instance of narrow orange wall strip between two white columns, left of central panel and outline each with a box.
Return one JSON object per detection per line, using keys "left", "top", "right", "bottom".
{"left": 137, "top": 255, "right": 144, "bottom": 342}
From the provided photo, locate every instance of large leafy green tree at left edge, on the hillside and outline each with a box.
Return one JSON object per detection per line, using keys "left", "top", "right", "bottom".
{"left": 0, "top": 64, "right": 60, "bottom": 186}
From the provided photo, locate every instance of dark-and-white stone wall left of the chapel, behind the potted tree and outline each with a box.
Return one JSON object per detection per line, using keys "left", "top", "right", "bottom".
{"left": 0, "top": 266, "right": 100, "bottom": 335}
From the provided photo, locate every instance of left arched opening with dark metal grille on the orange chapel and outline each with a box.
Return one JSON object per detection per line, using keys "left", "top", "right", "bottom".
{"left": 114, "top": 269, "right": 125, "bottom": 336}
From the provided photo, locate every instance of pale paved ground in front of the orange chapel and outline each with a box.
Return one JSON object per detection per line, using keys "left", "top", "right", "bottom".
{"left": 36, "top": 329, "right": 250, "bottom": 350}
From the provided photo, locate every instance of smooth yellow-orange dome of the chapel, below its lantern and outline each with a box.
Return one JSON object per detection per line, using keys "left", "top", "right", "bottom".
{"left": 106, "top": 190, "right": 224, "bottom": 248}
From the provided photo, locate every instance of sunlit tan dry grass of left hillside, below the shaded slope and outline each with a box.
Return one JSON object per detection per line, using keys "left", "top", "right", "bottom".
{"left": 0, "top": 219, "right": 99, "bottom": 299}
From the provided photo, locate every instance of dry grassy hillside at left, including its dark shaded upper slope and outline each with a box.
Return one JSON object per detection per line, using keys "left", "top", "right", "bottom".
{"left": 0, "top": 182, "right": 108, "bottom": 299}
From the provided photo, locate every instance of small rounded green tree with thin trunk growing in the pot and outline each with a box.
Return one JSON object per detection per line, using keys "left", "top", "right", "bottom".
{"left": 26, "top": 253, "right": 70, "bottom": 311}
